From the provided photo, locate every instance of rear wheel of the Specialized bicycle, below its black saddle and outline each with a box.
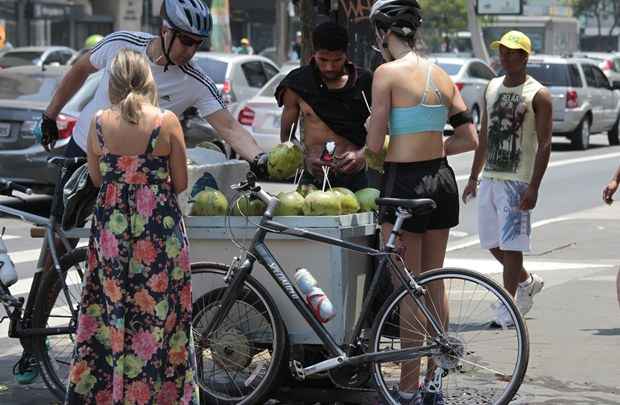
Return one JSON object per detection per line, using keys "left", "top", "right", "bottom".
{"left": 371, "top": 268, "right": 529, "bottom": 404}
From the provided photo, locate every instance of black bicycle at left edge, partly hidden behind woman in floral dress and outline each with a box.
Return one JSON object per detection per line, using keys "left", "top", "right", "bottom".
{"left": 0, "top": 157, "right": 88, "bottom": 400}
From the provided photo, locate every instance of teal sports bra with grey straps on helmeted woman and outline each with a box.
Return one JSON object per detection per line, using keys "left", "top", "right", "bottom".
{"left": 390, "top": 63, "right": 448, "bottom": 136}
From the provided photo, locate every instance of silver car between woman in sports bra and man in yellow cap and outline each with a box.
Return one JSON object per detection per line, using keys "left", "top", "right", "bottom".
{"left": 430, "top": 56, "right": 496, "bottom": 133}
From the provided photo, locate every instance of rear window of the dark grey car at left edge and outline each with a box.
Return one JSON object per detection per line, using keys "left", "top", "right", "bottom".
{"left": 0, "top": 72, "right": 62, "bottom": 101}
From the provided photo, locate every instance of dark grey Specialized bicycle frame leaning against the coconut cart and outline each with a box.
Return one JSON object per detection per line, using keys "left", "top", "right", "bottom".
{"left": 206, "top": 190, "right": 443, "bottom": 375}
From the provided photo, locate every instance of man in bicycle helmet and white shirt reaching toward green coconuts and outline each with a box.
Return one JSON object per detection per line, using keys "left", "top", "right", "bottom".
{"left": 15, "top": 0, "right": 267, "bottom": 383}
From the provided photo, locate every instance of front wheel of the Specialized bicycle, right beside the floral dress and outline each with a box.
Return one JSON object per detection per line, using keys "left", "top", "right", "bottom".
{"left": 192, "top": 262, "right": 287, "bottom": 405}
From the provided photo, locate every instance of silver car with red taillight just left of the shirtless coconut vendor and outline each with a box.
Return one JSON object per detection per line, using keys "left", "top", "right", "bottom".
{"left": 234, "top": 67, "right": 299, "bottom": 152}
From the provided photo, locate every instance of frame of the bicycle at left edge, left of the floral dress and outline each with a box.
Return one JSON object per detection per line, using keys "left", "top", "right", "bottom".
{"left": 0, "top": 205, "right": 77, "bottom": 338}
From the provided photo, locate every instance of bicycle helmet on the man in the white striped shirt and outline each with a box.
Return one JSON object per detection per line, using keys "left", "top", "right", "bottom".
{"left": 160, "top": 0, "right": 213, "bottom": 71}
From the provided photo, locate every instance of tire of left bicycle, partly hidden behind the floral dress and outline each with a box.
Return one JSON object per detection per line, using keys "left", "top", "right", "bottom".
{"left": 32, "top": 247, "right": 88, "bottom": 401}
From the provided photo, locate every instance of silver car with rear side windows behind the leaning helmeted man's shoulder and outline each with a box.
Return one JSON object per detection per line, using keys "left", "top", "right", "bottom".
{"left": 194, "top": 52, "right": 280, "bottom": 111}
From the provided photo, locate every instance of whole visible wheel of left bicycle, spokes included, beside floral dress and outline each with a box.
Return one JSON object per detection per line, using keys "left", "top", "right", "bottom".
{"left": 32, "top": 247, "right": 87, "bottom": 401}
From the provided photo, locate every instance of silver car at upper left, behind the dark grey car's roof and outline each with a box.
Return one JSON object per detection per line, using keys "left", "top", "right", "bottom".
{"left": 0, "top": 46, "right": 75, "bottom": 68}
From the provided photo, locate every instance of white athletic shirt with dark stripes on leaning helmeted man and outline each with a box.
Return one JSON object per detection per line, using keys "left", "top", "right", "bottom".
{"left": 73, "top": 31, "right": 225, "bottom": 151}
